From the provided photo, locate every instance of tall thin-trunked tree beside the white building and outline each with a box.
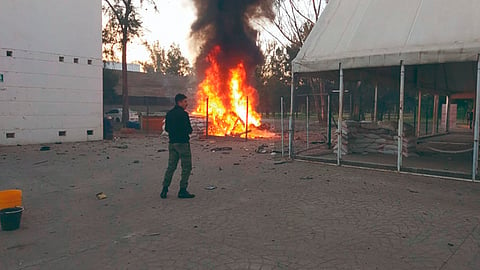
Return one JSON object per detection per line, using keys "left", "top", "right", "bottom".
{"left": 102, "top": 0, "right": 158, "bottom": 127}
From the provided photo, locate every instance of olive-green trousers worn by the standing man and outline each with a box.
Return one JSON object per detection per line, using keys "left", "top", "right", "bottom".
{"left": 163, "top": 143, "right": 192, "bottom": 188}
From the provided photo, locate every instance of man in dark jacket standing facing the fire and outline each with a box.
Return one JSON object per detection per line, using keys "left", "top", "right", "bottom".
{"left": 160, "top": 94, "right": 195, "bottom": 199}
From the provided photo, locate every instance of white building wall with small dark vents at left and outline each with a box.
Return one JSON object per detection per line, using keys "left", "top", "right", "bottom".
{"left": 0, "top": 0, "right": 103, "bottom": 145}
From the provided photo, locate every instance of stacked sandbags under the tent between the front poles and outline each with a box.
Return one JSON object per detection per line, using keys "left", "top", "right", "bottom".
{"left": 333, "top": 120, "right": 417, "bottom": 157}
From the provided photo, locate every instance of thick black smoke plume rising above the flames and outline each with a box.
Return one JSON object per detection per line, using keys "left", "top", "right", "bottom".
{"left": 191, "top": 0, "right": 274, "bottom": 81}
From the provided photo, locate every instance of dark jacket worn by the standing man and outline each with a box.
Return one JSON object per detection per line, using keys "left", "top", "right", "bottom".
{"left": 165, "top": 105, "right": 192, "bottom": 143}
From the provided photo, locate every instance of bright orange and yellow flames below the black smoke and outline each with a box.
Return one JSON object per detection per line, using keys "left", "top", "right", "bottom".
{"left": 194, "top": 46, "right": 272, "bottom": 138}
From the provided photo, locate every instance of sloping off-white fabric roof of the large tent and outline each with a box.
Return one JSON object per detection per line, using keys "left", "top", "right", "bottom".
{"left": 293, "top": 0, "right": 480, "bottom": 73}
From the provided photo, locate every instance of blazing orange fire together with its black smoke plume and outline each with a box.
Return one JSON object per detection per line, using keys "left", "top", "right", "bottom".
{"left": 191, "top": 0, "right": 274, "bottom": 137}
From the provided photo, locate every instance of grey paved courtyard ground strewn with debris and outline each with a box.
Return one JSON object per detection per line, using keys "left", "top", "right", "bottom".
{"left": 0, "top": 136, "right": 480, "bottom": 270}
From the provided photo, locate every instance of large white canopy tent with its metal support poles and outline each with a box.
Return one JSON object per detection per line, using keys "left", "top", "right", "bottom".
{"left": 289, "top": 0, "right": 480, "bottom": 179}
